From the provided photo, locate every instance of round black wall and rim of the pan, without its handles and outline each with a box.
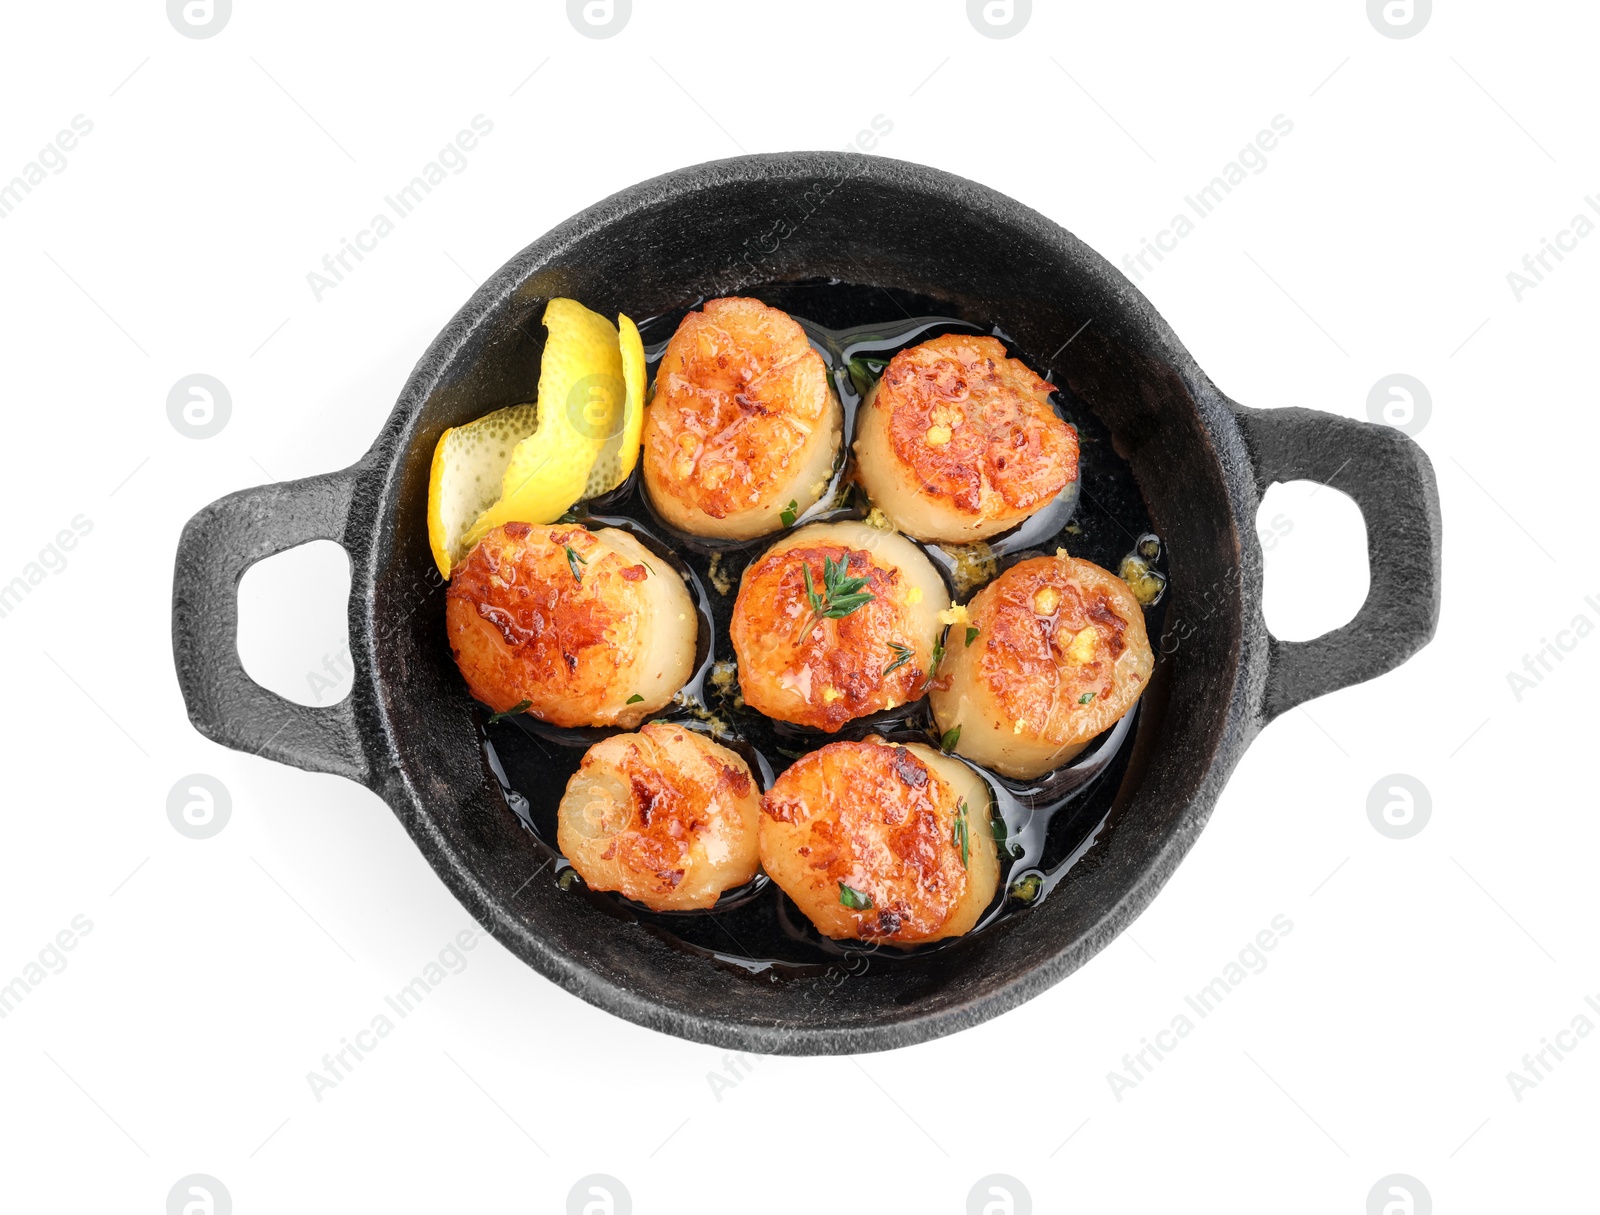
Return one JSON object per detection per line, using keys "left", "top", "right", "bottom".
{"left": 363, "top": 154, "right": 1248, "bottom": 1053}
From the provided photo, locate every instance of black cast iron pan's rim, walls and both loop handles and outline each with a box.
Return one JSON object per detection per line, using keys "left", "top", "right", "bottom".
{"left": 173, "top": 152, "right": 1440, "bottom": 1055}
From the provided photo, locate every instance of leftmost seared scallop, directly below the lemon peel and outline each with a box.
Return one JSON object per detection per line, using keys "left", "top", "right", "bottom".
{"left": 445, "top": 523, "right": 698, "bottom": 727}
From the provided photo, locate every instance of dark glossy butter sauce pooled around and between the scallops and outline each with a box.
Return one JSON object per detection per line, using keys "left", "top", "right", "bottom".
{"left": 483, "top": 282, "right": 1165, "bottom": 981}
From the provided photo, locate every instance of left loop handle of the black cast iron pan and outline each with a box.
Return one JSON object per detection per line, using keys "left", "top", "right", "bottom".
{"left": 173, "top": 467, "right": 373, "bottom": 784}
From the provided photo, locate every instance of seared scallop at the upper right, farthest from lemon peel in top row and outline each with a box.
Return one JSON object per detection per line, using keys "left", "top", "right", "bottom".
{"left": 856, "top": 333, "right": 1078, "bottom": 543}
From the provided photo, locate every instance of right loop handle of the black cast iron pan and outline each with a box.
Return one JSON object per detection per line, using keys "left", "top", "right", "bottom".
{"left": 1235, "top": 407, "right": 1443, "bottom": 724}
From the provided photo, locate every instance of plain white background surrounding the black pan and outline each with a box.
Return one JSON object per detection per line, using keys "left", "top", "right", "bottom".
{"left": 0, "top": 0, "right": 1600, "bottom": 1215}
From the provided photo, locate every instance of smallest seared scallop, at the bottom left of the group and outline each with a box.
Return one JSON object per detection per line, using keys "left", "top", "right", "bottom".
{"left": 555, "top": 722, "right": 762, "bottom": 911}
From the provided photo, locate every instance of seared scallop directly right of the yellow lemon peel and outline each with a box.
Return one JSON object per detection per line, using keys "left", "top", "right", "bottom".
{"left": 645, "top": 298, "right": 843, "bottom": 539}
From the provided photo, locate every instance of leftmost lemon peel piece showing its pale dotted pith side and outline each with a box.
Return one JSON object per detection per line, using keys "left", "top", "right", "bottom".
{"left": 427, "top": 405, "right": 539, "bottom": 578}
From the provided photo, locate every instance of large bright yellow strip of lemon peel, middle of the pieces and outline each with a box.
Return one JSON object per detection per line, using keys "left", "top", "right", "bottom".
{"left": 462, "top": 299, "right": 627, "bottom": 549}
